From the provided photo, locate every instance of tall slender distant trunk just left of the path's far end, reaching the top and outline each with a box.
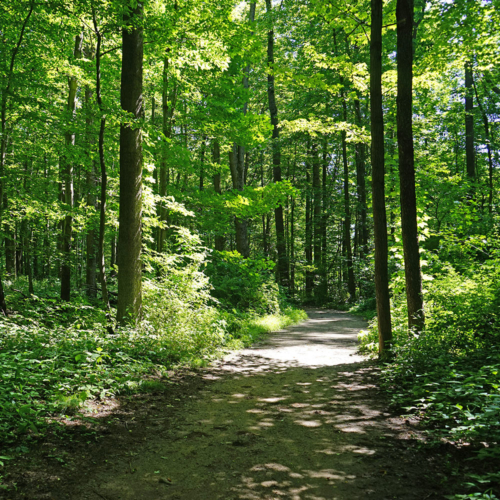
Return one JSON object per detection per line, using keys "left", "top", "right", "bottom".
{"left": 266, "top": 0, "right": 290, "bottom": 288}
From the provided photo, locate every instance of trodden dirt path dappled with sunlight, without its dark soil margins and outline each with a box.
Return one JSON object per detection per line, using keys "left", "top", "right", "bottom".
{"left": 47, "top": 311, "right": 442, "bottom": 500}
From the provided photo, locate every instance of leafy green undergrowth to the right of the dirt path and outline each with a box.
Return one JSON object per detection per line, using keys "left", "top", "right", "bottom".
{"left": 360, "top": 242, "right": 500, "bottom": 499}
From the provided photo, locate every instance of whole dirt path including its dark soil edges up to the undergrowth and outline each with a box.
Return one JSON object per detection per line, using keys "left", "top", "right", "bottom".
{"left": 0, "top": 309, "right": 468, "bottom": 500}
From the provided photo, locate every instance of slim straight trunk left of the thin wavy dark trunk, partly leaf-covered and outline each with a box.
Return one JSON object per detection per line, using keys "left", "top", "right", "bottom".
{"left": 61, "top": 34, "right": 83, "bottom": 301}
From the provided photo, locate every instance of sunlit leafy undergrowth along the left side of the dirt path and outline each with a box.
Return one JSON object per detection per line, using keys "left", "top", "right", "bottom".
{"left": 0, "top": 248, "right": 306, "bottom": 448}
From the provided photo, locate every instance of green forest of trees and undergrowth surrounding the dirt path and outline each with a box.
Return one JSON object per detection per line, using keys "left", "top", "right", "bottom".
{"left": 0, "top": 0, "right": 500, "bottom": 498}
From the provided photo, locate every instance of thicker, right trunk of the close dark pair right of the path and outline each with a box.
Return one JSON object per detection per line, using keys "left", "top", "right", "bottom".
{"left": 396, "top": 0, "right": 425, "bottom": 332}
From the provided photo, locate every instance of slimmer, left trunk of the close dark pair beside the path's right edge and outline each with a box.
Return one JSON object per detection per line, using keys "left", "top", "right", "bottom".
{"left": 370, "top": 0, "right": 392, "bottom": 357}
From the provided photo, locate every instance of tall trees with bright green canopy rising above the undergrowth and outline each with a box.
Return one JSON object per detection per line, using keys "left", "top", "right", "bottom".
{"left": 0, "top": 0, "right": 500, "bottom": 356}
